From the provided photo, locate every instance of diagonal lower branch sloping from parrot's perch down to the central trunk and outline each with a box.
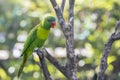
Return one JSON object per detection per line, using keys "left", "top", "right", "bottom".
{"left": 42, "top": 48, "right": 67, "bottom": 77}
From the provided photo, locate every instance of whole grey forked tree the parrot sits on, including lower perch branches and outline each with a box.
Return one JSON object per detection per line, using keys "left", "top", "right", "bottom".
{"left": 37, "top": 0, "right": 78, "bottom": 80}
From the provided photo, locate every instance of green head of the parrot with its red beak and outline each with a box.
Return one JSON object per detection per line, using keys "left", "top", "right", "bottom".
{"left": 42, "top": 16, "right": 56, "bottom": 29}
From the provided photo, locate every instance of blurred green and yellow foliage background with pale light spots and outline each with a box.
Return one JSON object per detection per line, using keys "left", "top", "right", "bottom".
{"left": 0, "top": 0, "right": 120, "bottom": 80}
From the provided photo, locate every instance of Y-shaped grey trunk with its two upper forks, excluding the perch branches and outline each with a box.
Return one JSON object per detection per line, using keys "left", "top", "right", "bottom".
{"left": 50, "top": 0, "right": 78, "bottom": 80}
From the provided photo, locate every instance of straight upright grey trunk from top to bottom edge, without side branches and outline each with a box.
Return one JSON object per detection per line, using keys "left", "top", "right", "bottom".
{"left": 66, "top": 0, "right": 77, "bottom": 80}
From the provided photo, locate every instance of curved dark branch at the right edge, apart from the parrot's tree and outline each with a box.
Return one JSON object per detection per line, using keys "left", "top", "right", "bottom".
{"left": 97, "top": 21, "right": 120, "bottom": 80}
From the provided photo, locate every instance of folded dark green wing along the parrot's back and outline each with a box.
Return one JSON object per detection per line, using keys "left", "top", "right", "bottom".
{"left": 21, "top": 26, "right": 38, "bottom": 56}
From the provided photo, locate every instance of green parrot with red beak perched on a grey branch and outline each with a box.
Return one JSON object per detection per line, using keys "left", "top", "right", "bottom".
{"left": 17, "top": 15, "right": 56, "bottom": 77}
